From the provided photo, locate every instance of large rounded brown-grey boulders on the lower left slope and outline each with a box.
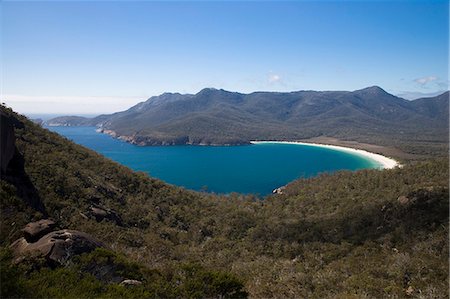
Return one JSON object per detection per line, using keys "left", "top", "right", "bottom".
{"left": 10, "top": 229, "right": 104, "bottom": 265}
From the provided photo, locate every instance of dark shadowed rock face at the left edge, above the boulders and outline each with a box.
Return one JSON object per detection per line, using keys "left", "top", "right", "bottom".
{"left": 0, "top": 110, "right": 46, "bottom": 214}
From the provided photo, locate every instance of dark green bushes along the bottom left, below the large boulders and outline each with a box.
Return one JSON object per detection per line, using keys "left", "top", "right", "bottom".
{"left": 0, "top": 248, "right": 247, "bottom": 298}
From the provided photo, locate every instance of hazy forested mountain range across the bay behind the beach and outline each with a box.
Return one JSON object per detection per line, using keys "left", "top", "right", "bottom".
{"left": 47, "top": 86, "right": 449, "bottom": 155}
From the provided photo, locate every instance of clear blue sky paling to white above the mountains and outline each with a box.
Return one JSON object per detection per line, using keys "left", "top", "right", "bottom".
{"left": 0, "top": 1, "right": 449, "bottom": 113}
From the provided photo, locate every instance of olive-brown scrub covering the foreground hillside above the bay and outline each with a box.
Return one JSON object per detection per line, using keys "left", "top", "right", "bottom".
{"left": 0, "top": 108, "right": 449, "bottom": 298}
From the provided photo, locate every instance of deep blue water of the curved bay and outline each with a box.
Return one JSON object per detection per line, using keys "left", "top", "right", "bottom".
{"left": 48, "top": 127, "right": 379, "bottom": 195}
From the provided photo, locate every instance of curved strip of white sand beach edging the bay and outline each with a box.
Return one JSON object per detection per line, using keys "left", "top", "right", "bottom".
{"left": 250, "top": 140, "right": 401, "bottom": 169}
